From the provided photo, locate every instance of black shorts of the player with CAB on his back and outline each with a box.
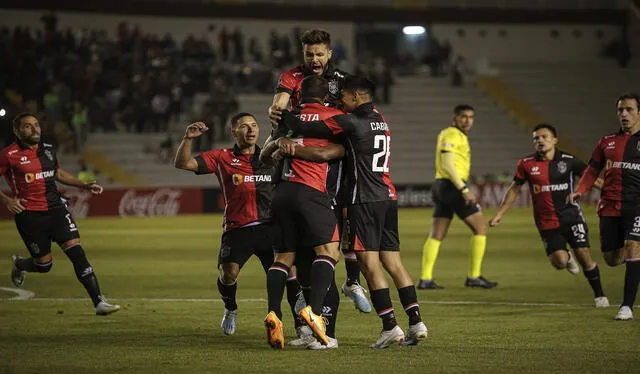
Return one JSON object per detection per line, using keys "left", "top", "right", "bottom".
{"left": 348, "top": 200, "right": 400, "bottom": 252}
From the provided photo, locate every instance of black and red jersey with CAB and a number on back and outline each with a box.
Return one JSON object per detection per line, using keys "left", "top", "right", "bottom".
{"left": 283, "top": 102, "right": 397, "bottom": 204}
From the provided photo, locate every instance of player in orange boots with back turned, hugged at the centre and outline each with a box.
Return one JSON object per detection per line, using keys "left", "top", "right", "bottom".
{"left": 265, "top": 75, "right": 344, "bottom": 349}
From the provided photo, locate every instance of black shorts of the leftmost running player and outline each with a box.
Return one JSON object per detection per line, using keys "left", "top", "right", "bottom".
{"left": 14, "top": 208, "right": 80, "bottom": 258}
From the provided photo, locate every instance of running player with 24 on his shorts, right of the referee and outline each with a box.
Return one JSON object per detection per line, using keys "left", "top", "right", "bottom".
{"left": 489, "top": 124, "right": 609, "bottom": 308}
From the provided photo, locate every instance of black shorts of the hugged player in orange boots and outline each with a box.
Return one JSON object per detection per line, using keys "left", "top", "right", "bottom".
{"left": 271, "top": 182, "right": 340, "bottom": 253}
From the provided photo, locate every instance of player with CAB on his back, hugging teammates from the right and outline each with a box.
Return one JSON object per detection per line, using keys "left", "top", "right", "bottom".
{"left": 282, "top": 77, "right": 427, "bottom": 348}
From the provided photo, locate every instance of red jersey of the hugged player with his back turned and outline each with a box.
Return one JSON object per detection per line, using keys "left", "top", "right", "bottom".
{"left": 282, "top": 102, "right": 344, "bottom": 192}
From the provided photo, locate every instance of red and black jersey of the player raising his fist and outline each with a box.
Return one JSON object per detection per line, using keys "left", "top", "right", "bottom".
{"left": 195, "top": 146, "right": 273, "bottom": 231}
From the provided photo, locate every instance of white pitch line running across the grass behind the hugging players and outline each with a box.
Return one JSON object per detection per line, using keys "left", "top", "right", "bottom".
{"left": 0, "top": 294, "right": 593, "bottom": 307}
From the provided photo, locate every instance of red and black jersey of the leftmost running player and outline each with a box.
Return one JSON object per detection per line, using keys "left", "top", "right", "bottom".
{"left": 0, "top": 141, "right": 63, "bottom": 211}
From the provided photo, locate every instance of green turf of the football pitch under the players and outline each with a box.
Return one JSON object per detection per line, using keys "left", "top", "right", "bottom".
{"left": 0, "top": 209, "right": 640, "bottom": 373}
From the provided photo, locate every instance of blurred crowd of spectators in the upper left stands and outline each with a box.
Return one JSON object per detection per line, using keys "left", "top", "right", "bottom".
{"left": 0, "top": 13, "right": 346, "bottom": 152}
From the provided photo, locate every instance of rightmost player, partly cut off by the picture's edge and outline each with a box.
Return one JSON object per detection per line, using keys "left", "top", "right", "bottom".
{"left": 569, "top": 94, "right": 640, "bottom": 321}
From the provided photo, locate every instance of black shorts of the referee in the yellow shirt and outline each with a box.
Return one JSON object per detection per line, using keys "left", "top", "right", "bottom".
{"left": 431, "top": 179, "right": 480, "bottom": 219}
